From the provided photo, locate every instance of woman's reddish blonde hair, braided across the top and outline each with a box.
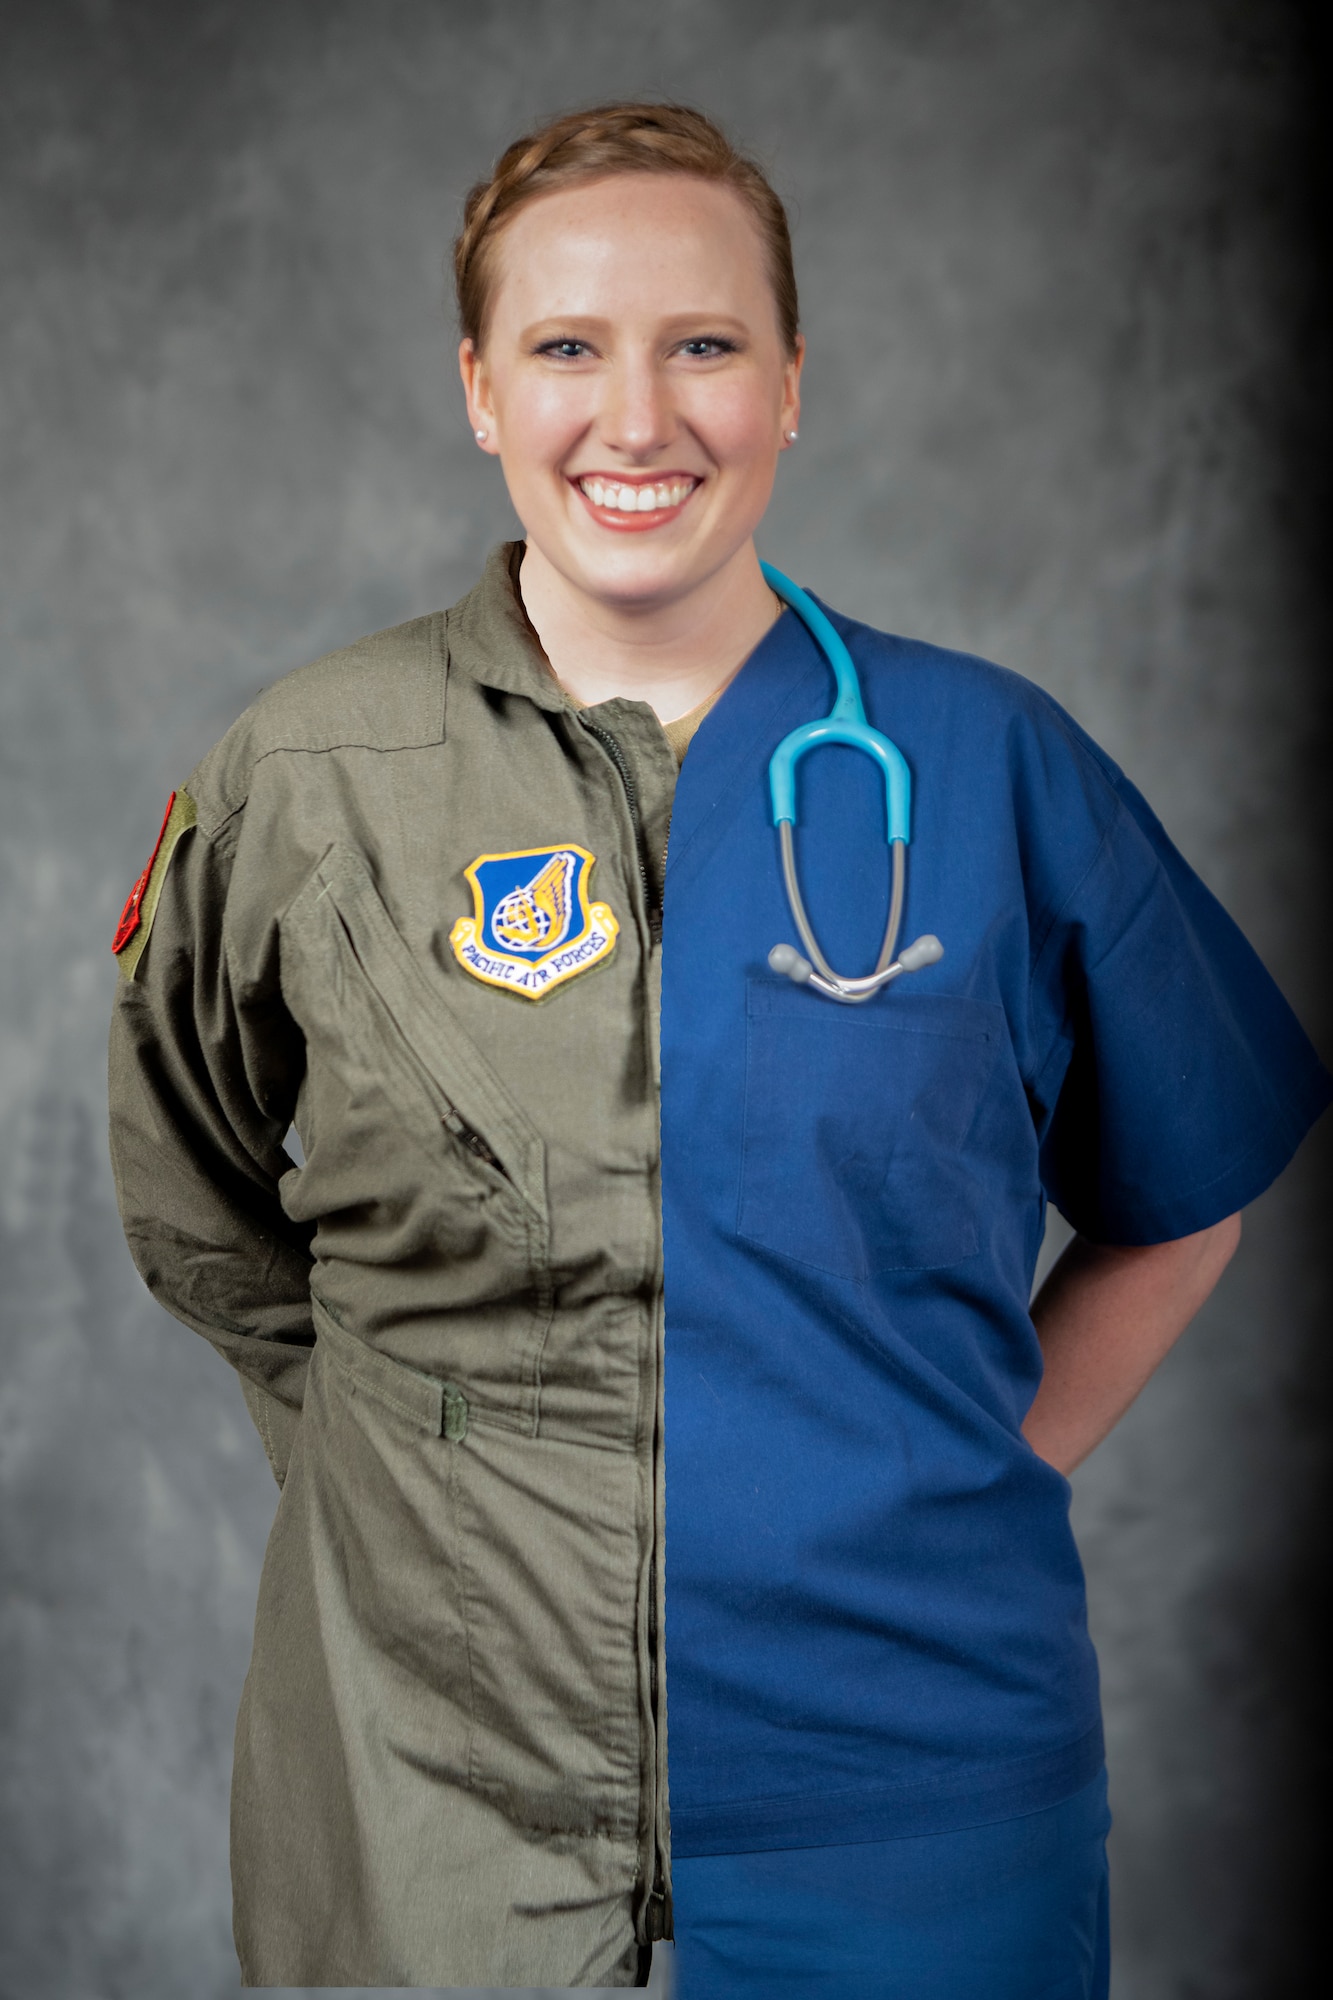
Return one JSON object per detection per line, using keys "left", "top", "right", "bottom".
{"left": 454, "top": 104, "right": 801, "bottom": 354}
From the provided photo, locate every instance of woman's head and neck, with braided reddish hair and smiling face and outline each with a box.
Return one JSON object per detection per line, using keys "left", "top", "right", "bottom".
{"left": 456, "top": 106, "right": 805, "bottom": 722}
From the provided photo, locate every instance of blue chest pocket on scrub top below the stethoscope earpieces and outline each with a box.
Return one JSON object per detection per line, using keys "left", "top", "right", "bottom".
{"left": 737, "top": 980, "right": 1005, "bottom": 1278}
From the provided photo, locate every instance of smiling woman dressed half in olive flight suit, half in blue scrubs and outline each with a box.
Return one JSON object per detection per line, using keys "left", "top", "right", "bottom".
{"left": 112, "top": 106, "right": 1329, "bottom": 2000}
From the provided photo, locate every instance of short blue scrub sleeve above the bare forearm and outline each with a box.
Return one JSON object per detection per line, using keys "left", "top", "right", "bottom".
{"left": 1031, "top": 746, "right": 1333, "bottom": 1244}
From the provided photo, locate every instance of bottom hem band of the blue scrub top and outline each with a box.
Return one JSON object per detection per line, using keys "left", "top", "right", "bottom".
{"left": 671, "top": 1720, "right": 1105, "bottom": 1858}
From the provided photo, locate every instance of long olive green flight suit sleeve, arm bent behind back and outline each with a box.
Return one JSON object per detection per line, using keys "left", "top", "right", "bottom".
{"left": 110, "top": 794, "right": 314, "bottom": 1480}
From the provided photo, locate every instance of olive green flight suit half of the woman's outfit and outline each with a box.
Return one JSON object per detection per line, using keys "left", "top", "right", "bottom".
{"left": 110, "top": 544, "right": 677, "bottom": 1986}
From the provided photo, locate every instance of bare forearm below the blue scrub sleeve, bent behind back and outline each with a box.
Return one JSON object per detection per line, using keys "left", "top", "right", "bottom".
{"left": 1023, "top": 1214, "right": 1241, "bottom": 1474}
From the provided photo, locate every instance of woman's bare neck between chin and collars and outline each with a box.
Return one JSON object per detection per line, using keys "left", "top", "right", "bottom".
{"left": 518, "top": 542, "right": 783, "bottom": 722}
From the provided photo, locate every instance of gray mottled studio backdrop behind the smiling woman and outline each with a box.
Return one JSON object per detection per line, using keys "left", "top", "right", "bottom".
{"left": 0, "top": 0, "right": 1329, "bottom": 2000}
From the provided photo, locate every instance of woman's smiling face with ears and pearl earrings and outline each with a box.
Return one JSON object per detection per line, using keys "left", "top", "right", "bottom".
{"left": 458, "top": 174, "right": 801, "bottom": 610}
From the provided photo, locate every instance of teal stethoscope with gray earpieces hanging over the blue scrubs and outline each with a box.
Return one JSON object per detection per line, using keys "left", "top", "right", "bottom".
{"left": 759, "top": 562, "right": 932, "bottom": 1006}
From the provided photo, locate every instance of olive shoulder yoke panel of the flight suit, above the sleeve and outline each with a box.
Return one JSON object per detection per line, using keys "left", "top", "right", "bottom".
{"left": 186, "top": 612, "right": 446, "bottom": 836}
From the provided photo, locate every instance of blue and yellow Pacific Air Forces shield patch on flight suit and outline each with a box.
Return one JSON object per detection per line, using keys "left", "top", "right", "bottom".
{"left": 448, "top": 842, "right": 620, "bottom": 1000}
